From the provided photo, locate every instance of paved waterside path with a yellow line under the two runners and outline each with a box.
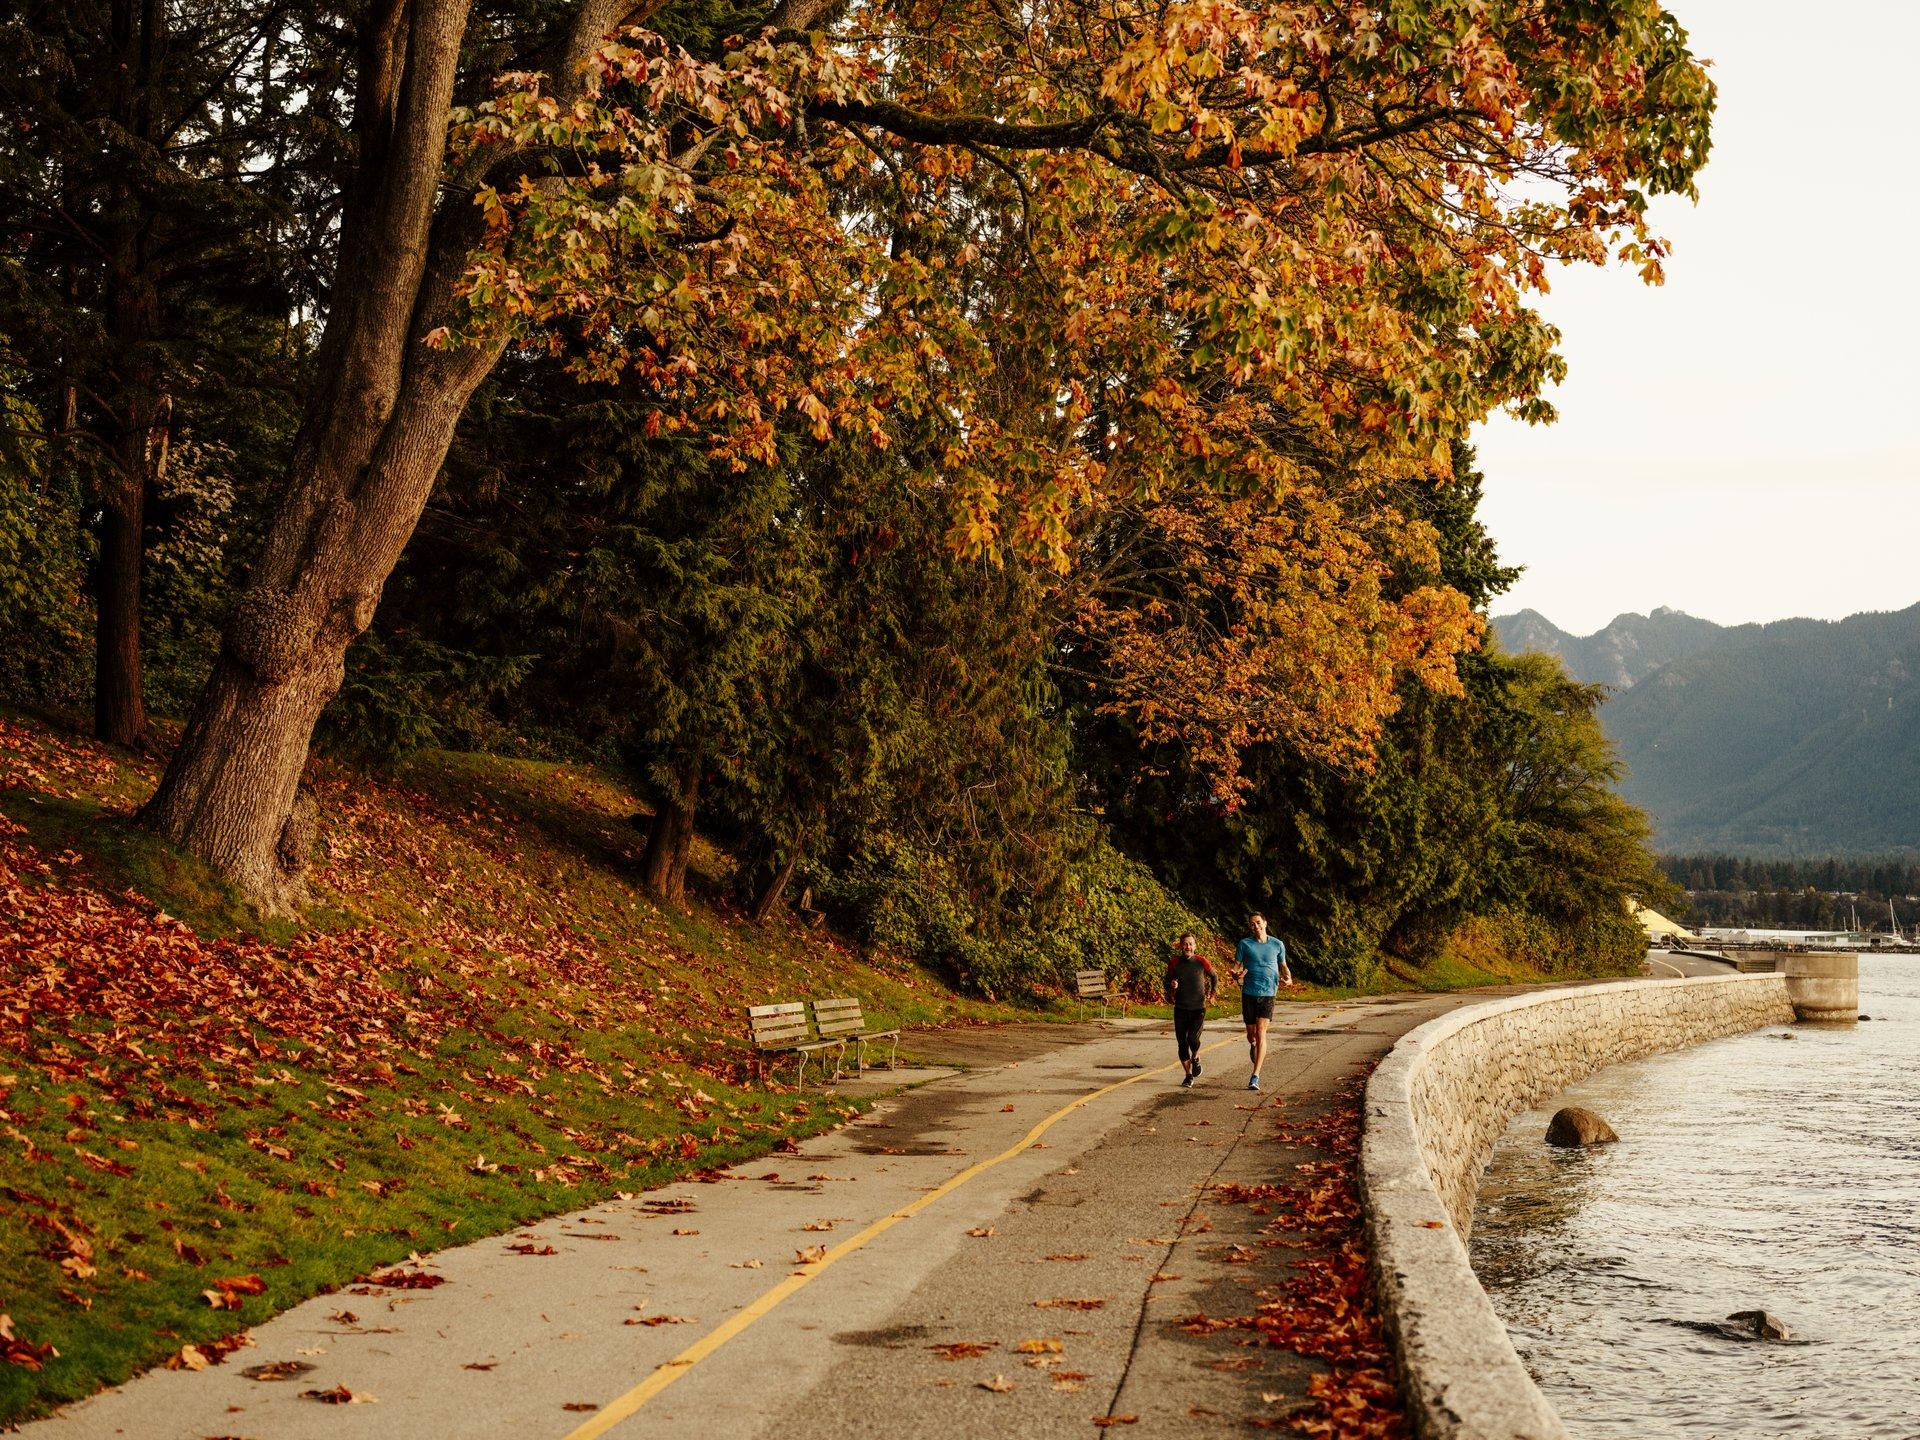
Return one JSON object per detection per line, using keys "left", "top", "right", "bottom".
{"left": 23, "top": 991, "right": 1528, "bottom": 1440}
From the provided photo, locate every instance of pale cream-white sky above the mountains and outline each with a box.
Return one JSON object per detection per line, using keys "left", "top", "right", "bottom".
{"left": 1476, "top": 0, "right": 1920, "bottom": 634}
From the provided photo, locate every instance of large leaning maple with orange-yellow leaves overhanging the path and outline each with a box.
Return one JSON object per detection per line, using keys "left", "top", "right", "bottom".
{"left": 86, "top": 0, "right": 1713, "bottom": 908}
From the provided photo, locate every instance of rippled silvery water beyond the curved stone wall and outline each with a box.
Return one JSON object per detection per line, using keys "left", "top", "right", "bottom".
{"left": 1471, "top": 956, "right": 1920, "bottom": 1440}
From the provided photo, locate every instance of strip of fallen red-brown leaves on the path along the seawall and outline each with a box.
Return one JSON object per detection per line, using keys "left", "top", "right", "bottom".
{"left": 1181, "top": 1068, "right": 1413, "bottom": 1440}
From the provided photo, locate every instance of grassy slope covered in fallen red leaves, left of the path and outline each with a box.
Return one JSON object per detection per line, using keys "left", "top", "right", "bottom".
{"left": 0, "top": 714, "right": 1013, "bottom": 1425}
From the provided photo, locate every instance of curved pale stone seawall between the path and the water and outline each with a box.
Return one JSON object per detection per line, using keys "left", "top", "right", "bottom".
{"left": 1361, "top": 975, "right": 1793, "bottom": 1440}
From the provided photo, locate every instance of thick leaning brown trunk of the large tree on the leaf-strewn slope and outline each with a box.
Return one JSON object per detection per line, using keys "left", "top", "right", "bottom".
{"left": 142, "top": 0, "right": 620, "bottom": 912}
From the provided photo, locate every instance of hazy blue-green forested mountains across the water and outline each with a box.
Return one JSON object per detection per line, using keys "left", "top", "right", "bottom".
{"left": 1494, "top": 605, "right": 1920, "bottom": 856}
